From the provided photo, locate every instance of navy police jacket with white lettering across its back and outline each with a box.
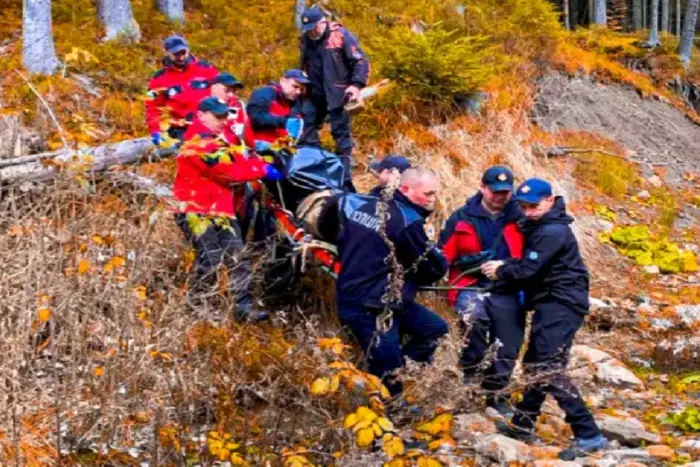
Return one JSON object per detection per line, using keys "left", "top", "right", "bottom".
{"left": 330, "top": 192, "right": 447, "bottom": 309}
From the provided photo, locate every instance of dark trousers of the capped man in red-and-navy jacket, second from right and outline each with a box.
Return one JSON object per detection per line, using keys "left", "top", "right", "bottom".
{"left": 457, "top": 290, "right": 526, "bottom": 391}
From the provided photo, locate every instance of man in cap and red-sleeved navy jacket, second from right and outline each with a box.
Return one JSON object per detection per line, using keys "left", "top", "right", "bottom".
{"left": 440, "top": 166, "right": 525, "bottom": 413}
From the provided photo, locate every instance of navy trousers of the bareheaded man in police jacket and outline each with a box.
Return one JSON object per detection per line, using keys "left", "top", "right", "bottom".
{"left": 338, "top": 302, "right": 448, "bottom": 396}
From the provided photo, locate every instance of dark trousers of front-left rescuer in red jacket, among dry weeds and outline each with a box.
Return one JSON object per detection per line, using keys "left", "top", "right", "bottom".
{"left": 175, "top": 214, "right": 253, "bottom": 314}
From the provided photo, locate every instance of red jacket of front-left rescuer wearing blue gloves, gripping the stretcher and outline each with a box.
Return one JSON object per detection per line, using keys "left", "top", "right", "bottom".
{"left": 173, "top": 120, "right": 266, "bottom": 217}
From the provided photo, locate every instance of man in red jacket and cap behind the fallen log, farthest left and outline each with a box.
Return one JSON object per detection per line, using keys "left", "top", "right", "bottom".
{"left": 146, "top": 36, "right": 219, "bottom": 146}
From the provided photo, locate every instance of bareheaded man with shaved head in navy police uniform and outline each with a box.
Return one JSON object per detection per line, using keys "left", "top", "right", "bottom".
{"left": 322, "top": 168, "right": 448, "bottom": 396}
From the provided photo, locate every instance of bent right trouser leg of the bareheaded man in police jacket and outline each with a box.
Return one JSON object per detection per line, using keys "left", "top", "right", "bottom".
{"left": 398, "top": 302, "right": 448, "bottom": 363}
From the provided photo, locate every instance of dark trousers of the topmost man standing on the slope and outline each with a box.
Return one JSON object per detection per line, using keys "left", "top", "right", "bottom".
{"left": 299, "top": 97, "right": 353, "bottom": 186}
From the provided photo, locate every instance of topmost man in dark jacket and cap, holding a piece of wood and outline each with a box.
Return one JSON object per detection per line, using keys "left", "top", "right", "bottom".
{"left": 301, "top": 8, "right": 369, "bottom": 179}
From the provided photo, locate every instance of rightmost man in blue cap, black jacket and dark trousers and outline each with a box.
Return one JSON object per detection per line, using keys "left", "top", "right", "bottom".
{"left": 481, "top": 178, "right": 608, "bottom": 460}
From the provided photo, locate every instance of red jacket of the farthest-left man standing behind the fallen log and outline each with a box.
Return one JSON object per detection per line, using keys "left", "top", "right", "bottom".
{"left": 146, "top": 57, "right": 219, "bottom": 133}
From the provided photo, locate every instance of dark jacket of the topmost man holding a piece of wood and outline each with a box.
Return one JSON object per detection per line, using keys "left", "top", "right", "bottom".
{"left": 300, "top": 23, "right": 369, "bottom": 110}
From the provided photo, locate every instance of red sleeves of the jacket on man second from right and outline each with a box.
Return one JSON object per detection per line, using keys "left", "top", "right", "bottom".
{"left": 440, "top": 194, "right": 525, "bottom": 305}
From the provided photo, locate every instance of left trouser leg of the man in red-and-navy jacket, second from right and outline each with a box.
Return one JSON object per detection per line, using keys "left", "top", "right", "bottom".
{"left": 456, "top": 290, "right": 489, "bottom": 376}
